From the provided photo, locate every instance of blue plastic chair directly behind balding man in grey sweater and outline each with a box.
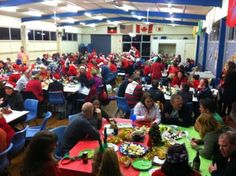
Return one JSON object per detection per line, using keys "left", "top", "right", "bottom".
{"left": 50, "top": 125, "right": 66, "bottom": 160}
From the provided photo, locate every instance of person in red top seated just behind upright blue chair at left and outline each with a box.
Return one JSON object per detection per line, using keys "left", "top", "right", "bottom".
{"left": 25, "top": 75, "right": 43, "bottom": 102}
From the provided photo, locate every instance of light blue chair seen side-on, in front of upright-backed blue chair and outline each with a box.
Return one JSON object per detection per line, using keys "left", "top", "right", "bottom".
{"left": 26, "top": 111, "right": 52, "bottom": 140}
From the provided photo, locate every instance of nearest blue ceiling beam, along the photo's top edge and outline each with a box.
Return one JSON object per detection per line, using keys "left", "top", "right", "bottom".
{"left": 128, "top": 0, "right": 222, "bottom": 7}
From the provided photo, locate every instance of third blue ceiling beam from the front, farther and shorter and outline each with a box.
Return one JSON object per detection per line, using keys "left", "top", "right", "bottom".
{"left": 58, "top": 17, "right": 197, "bottom": 26}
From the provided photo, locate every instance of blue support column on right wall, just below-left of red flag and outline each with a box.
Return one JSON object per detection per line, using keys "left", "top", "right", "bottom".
{"left": 216, "top": 18, "right": 226, "bottom": 85}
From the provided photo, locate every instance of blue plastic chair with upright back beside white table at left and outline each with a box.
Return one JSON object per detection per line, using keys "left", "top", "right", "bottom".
{"left": 24, "top": 99, "right": 39, "bottom": 125}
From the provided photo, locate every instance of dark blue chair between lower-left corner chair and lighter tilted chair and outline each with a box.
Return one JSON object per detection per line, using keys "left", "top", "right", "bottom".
{"left": 9, "top": 125, "right": 29, "bottom": 158}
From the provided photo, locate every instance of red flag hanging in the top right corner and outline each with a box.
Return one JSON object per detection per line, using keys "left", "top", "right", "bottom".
{"left": 226, "top": 0, "right": 236, "bottom": 27}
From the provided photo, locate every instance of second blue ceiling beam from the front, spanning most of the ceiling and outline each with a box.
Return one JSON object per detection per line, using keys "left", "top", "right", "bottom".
{"left": 22, "top": 8, "right": 206, "bottom": 22}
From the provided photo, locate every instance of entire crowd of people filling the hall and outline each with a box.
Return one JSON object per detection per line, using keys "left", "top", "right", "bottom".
{"left": 0, "top": 47, "right": 236, "bottom": 176}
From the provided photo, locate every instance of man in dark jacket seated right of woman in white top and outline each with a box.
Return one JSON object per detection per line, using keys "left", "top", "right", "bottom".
{"left": 161, "top": 94, "right": 192, "bottom": 127}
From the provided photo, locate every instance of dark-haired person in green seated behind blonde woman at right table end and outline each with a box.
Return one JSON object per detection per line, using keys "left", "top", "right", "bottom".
{"left": 194, "top": 98, "right": 224, "bottom": 131}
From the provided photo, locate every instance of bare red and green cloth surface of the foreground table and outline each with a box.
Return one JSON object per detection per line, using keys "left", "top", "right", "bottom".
{"left": 59, "top": 119, "right": 211, "bottom": 176}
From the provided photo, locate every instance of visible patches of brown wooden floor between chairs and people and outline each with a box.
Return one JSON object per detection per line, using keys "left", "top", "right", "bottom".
{"left": 8, "top": 101, "right": 116, "bottom": 176}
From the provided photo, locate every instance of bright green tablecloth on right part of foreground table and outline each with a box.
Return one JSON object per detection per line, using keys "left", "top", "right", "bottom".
{"left": 139, "top": 127, "right": 211, "bottom": 176}
